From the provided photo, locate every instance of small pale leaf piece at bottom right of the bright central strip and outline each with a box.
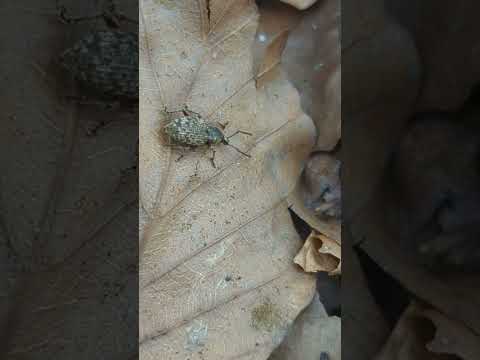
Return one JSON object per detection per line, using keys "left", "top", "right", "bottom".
{"left": 269, "top": 295, "right": 342, "bottom": 360}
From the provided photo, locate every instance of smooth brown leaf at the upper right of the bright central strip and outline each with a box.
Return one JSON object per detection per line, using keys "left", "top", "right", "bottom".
{"left": 282, "top": 0, "right": 341, "bottom": 151}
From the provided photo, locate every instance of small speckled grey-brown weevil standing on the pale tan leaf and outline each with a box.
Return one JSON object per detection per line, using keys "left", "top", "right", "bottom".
{"left": 163, "top": 106, "right": 252, "bottom": 167}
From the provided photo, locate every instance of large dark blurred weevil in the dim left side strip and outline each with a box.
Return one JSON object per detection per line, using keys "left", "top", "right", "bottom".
{"left": 57, "top": 1, "right": 139, "bottom": 133}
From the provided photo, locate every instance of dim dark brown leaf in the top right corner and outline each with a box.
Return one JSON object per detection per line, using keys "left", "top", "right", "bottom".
{"left": 409, "top": 0, "right": 480, "bottom": 111}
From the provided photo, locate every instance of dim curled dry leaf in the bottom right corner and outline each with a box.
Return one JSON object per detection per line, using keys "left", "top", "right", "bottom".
{"left": 377, "top": 303, "right": 480, "bottom": 360}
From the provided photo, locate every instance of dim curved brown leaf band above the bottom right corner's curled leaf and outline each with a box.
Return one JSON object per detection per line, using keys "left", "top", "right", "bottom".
{"left": 350, "top": 182, "right": 480, "bottom": 333}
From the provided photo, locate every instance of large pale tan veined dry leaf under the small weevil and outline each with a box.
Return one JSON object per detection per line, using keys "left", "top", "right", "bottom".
{"left": 139, "top": 0, "right": 315, "bottom": 360}
